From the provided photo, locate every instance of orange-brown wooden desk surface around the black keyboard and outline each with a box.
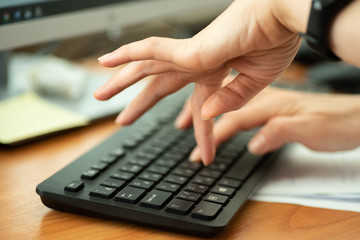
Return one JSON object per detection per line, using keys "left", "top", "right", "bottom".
{"left": 0, "top": 121, "right": 360, "bottom": 240}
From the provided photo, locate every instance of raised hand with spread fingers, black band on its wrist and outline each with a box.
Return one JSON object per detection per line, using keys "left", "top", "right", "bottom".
{"left": 95, "top": 0, "right": 309, "bottom": 164}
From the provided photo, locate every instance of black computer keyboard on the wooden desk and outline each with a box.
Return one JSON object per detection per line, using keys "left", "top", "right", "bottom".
{"left": 36, "top": 89, "right": 279, "bottom": 236}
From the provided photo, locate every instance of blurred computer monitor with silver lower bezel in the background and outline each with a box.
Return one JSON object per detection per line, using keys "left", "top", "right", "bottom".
{"left": 0, "top": 0, "right": 232, "bottom": 99}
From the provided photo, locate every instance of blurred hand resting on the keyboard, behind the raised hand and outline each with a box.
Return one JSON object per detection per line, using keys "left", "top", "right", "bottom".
{"left": 176, "top": 87, "right": 360, "bottom": 160}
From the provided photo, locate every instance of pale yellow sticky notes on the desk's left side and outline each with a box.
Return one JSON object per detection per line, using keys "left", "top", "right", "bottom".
{"left": 0, "top": 92, "right": 89, "bottom": 144}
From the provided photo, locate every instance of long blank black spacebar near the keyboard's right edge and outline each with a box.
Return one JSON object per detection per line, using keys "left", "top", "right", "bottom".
{"left": 225, "top": 152, "right": 263, "bottom": 181}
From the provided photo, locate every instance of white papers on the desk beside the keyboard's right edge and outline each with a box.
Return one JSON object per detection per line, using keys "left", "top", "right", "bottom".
{"left": 252, "top": 144, "right": 360, "bottom": 212}
